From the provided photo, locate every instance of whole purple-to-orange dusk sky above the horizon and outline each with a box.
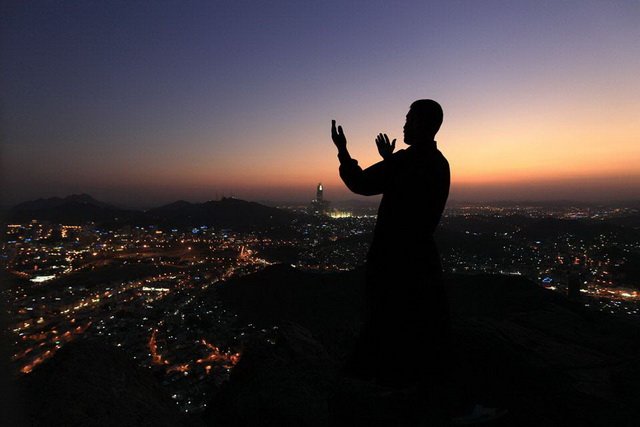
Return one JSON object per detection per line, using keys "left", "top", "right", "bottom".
{"left": 0, "top": 0, "right": 640, "bottom": 206}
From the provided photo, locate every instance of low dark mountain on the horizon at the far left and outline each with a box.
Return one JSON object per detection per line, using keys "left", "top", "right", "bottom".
{"left": 7, "top": 194, "right": 139, "bottom": 225}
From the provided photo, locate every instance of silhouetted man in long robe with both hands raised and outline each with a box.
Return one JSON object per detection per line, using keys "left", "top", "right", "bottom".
{"left": 331, "top": 99, "right": 450, "bottom": 394}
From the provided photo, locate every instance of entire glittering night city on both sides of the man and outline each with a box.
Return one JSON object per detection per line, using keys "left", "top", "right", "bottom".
{"left": 0, "top": 193, "right": 640, "bottom": 412}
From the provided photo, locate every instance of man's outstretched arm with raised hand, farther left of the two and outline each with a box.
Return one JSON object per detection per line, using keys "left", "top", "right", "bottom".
{"left": 331, "top": 120, "right": 388, "bottom": 196}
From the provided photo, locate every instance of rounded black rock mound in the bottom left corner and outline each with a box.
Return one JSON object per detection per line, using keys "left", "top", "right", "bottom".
{"left": 16, "top": 340, "right": 194, "bottom": 427}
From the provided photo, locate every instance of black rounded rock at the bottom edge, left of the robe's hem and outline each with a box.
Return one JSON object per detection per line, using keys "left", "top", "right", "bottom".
{"left": 204, "top": 324, "right": 335, "bottom": 427}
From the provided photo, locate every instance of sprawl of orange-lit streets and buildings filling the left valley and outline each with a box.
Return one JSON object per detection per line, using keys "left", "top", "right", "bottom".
{"left": 2, "top": 221, "right": 271, "bottom": 411}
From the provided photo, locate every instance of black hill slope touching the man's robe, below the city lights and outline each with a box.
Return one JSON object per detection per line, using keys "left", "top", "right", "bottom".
{"left": 216, "top": 264, "right": 364, "bottom": 361}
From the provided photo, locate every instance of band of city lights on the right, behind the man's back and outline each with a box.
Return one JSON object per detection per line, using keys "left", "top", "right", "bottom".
{"left": 442, "top": 206, "right": 640, "bottom": 315}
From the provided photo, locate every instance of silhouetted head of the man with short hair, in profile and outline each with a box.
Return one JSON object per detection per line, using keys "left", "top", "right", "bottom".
{"left": 404, "top": 99, "right": 442, "bottom": 145}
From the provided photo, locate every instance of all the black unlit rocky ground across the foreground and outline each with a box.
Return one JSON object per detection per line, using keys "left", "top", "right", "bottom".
{"left": 7, "top": 265, "right": 640, "bottom": 427}
